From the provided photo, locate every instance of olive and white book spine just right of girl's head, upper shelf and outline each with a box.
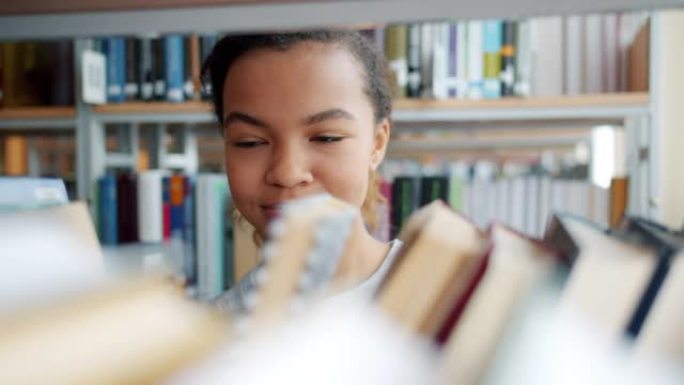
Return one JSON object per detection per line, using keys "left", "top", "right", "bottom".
{"left": 385, "top": 25, "right": 408, "bottom": 99}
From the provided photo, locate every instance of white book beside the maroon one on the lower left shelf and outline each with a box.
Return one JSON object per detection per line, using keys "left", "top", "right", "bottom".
{"left": 138, "top": 170, "right": 168, "bottom": 243}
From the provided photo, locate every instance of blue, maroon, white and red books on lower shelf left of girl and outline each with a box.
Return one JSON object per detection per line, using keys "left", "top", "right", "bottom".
{"left": 94, "top": 170, "right": 234, "bottom": 298}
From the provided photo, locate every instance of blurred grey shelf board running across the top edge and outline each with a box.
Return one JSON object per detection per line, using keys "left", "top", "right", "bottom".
{"left": 0, "top": 0, "right": 681, "bottom": 40}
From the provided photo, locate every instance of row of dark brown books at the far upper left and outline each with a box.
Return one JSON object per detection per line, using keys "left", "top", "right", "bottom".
{"left": 0, "top": 40, "right": 74, "bottom": 107}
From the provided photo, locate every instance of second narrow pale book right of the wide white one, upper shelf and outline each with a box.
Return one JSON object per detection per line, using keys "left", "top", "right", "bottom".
{"left": 584, "top": 14, "right": 604, "bottom": 94}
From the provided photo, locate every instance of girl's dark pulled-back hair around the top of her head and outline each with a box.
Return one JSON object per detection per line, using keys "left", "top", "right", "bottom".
{"left": 202, "top": 29, "right": 392, "bottom": 126}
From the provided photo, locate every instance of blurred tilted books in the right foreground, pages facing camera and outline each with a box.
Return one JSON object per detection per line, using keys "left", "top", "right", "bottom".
{"left": 377, "top": 201, "right": 684, "bottom": 384}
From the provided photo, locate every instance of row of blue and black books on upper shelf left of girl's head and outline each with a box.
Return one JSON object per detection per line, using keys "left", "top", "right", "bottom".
{"left": 94, "top": 34, "right": 217, "bottom": 103}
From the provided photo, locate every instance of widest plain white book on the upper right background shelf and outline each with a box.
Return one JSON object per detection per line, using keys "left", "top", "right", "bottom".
{"left": 530, "top": 16, "right": 563, "bottom": 96}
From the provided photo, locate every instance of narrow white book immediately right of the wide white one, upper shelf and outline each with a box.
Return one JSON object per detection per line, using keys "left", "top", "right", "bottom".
{"left": 563, "top": 15, "right": 584, "bottom": 95}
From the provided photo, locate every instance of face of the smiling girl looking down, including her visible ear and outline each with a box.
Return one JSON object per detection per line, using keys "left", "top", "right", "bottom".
{"left": 223, "top": 42, "right": 389, "bottom": 236}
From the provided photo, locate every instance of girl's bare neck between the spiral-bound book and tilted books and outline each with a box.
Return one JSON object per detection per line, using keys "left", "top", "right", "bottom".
{"left": 333, "top": 220, "right": 389, "bottom": 290}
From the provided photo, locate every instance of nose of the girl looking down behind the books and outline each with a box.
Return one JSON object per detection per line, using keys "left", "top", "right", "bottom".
{"left": 266, "top": 145, "right": 313, "bottom": 188}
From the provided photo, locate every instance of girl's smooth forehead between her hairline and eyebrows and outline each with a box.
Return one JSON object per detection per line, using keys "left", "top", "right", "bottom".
{"left": 223, "top": 42, "right": 370, "bottom": 117}
